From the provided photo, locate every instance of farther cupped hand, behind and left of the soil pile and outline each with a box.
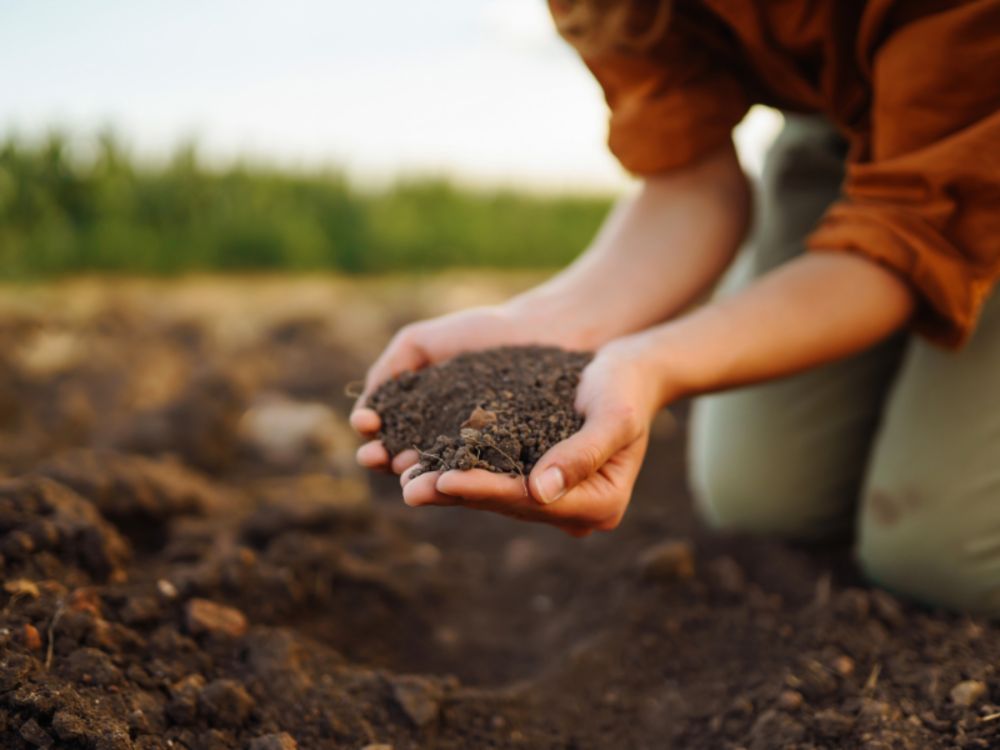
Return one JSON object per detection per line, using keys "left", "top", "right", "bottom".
{"left": 351, "top": 305, "right": 580, "bottom": 474}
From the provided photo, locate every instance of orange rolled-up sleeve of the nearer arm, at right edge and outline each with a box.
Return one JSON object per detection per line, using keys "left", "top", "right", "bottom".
{"left": 808, "top": 0, "right": 1000, "bottom": 348}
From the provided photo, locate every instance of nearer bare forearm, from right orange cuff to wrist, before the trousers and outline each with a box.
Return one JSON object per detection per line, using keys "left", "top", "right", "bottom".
{"left": 630, "top": 253, "right": 915, "bottom": 403}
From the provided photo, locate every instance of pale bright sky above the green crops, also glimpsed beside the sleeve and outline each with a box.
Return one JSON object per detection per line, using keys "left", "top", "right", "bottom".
{"left": 0, "top": 0, "right": 778, "bottom": 188}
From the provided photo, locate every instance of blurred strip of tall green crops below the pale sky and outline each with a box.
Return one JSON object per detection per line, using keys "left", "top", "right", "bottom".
{"left": 0, "top": 135, "right": 611, "bottom": 279}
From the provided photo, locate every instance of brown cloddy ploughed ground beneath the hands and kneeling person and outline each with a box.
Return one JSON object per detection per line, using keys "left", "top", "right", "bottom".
{"left": 0, "top": 281, "right": 1000, "bottom": 750}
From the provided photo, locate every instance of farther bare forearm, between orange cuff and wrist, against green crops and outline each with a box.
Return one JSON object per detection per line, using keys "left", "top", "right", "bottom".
{"left": 511, "top": 147, "right": 750, "bottom": 348}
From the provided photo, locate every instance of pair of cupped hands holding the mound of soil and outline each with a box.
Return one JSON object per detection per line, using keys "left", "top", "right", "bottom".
{"left": 351, "top": 306, "right": 661, "bottom": 536}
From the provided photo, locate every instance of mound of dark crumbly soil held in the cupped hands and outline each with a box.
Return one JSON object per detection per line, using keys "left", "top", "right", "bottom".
{"left": 368, "top": 346, "right": 593, "bottom": 476}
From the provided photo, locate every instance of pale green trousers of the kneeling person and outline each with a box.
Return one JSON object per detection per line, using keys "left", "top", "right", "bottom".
{"left": 689, "top": 116, "right": 1000, "bottom": 615}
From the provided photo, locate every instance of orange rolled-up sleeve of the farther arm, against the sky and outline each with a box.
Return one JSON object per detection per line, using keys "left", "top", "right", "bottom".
{"left": 553, "top": 4, "right": 749, "bottom": 175}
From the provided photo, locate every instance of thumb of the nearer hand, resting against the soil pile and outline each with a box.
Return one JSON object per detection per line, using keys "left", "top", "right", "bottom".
{"left": 528, "top": 406, "right": 641, "bottom": 505}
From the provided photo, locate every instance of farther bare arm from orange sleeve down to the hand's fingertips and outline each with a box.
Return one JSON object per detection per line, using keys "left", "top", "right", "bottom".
{"left": 351, "top": 145, "right": 750, "bottom": 472}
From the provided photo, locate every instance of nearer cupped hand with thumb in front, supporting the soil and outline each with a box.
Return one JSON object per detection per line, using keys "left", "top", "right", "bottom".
{"left": 401, "top": 335, "right": 663, "bottom": 536}
